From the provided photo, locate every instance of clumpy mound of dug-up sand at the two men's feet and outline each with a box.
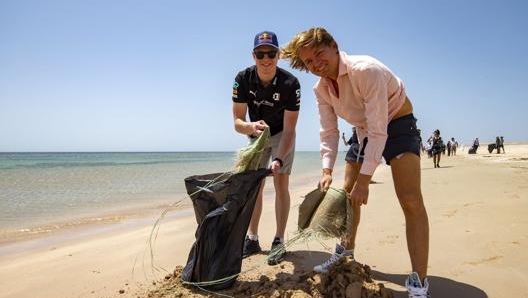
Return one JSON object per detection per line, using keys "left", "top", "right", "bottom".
{"left": 137, "top": 252, "right": 394, "bottom": 298}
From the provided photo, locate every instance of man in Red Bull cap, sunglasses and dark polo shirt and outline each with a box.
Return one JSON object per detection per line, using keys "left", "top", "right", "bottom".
{"left": 232, "top": 31, "right": 301, "bottom": 265}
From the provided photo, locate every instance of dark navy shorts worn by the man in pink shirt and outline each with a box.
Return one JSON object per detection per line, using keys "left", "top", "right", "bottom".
{"left": 345, "top": 114, "right": 420, "bottom": 165}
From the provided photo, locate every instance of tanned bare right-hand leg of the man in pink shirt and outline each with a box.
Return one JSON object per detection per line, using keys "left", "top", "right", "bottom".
{"left": 391, "top": 152, "right": 429, "bottom": 279}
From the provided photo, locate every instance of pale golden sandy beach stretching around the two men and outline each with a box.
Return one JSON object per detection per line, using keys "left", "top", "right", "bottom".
{"left": 0, "top": 143, "right": 528, "bottom": 298}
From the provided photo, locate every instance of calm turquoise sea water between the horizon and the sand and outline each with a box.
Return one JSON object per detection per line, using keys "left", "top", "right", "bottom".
{"left": 0, "top": 152, "right": 320, "bottom": 239}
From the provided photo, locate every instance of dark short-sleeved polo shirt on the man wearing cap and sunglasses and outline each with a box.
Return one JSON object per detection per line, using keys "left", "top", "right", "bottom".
{"left": 232, "top": 65, "right": 301, "bottom": 135}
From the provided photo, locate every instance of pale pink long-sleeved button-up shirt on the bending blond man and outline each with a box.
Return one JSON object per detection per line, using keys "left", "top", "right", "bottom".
{"left": 314, "top": 52, "right": 406, "bottom": 175}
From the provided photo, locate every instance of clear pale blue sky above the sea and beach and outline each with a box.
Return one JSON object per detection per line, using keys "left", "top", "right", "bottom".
{"left": 0, "top": 0, "right": 528, "bottom": 151}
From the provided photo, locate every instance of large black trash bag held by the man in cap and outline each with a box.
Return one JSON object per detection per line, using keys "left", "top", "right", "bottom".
{"left": 181, "top": 169, "right": 270, "bottom": 291}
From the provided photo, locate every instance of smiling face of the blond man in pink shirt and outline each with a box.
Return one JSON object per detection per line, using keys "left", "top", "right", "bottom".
{"left": 299, "top": 43, "right": 339, "bottom": 80}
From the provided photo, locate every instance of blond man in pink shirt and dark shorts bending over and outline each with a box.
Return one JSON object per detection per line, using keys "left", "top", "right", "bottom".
{"left": 282, "top": 27, "right": 429, "bottom": 298}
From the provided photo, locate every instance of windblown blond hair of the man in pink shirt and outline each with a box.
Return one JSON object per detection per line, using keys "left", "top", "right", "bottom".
{"left": 281, "top": 27, "right": 337, "bottom": 71}
